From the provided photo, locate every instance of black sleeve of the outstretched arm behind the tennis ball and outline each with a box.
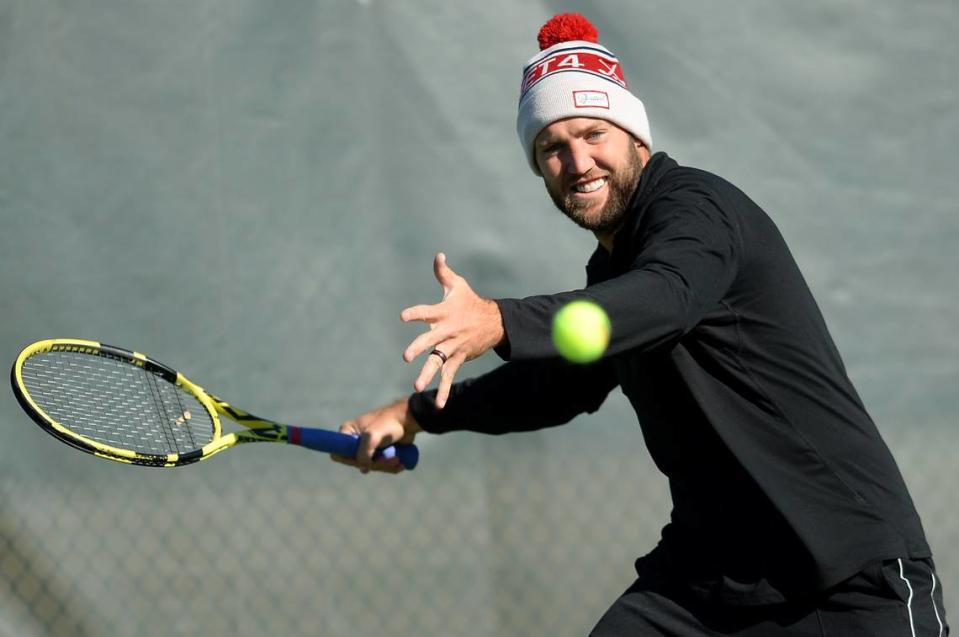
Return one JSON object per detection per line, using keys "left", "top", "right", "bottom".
{"left": 496, "top": 198, "right": 742, "bottom": 361}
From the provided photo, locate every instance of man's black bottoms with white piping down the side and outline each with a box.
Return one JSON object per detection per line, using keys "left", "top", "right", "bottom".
{"left": 590, "top": 559, "right": 949, "bottom": 637}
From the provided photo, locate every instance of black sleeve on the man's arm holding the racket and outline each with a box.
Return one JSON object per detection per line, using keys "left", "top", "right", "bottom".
{"left": 408, "top": 359, "right": 617, "bottom": 434}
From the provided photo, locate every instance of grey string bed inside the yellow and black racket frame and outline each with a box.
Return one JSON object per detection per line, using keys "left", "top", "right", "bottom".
{"left": 21, "top": 351, "right": 213, "bottom": 455}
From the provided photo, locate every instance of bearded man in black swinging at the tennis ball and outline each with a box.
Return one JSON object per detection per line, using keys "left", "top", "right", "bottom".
{"left": 341, "top": 15, "right": 948, "bottom": 637}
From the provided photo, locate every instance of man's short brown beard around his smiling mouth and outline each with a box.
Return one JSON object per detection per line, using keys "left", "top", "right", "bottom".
{"left": 546, "top": 144, "right": 643, "bottom": 234}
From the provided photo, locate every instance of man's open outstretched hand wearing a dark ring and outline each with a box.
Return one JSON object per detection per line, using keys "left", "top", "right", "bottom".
{"left": 400, "top": 252, "right": 504, "bottom": 409}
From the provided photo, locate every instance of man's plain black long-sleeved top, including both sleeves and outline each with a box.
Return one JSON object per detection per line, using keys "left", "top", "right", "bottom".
{"left": 409, "top": 153, "right": 930, "bottom": 603}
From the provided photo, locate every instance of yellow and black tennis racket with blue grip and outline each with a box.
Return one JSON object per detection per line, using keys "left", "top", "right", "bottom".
{"left": 10, "top": 338, "right": 419, "bottom": 469}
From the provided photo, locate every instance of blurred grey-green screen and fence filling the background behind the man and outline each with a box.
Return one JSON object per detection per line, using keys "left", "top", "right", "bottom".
{"left": 0, "top": 0, "right": 959, "bottom": 637}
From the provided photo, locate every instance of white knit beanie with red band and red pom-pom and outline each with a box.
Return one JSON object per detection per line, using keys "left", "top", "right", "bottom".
{"left": 516, "top": 13, "right": 653, "bottom": 175}
